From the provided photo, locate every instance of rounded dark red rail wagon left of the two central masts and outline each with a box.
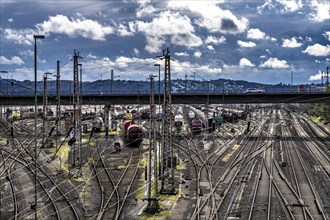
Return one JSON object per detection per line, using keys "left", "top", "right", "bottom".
{"left": 124, "top": 120, "right": 143, "bottom": 147}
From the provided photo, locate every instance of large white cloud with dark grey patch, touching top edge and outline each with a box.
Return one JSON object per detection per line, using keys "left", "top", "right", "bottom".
{"left": 168, "top": 0, "right": 249, "bottom": 34}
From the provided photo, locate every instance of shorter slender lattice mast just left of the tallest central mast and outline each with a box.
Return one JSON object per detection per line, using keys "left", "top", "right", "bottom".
{"left": 145, "top": 75, "right": 159, "bottom": 213}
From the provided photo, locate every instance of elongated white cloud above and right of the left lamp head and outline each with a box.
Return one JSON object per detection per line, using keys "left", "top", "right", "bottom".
{"left": 36, "top": 15, "right": 114, "bottom": 41}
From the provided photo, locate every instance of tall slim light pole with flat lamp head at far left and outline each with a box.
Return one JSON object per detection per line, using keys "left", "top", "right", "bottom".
{"left": 33, "top": 35, "right": 45, "bottom": 219}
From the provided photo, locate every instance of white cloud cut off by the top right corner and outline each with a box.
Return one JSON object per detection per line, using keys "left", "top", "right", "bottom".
{"left": 310, "top": 0, "right": 330, "bottom": 22}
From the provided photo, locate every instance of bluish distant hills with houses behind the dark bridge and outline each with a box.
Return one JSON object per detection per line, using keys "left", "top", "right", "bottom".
{"left": 0, "top": 79, "right": 319, "bottom": 95}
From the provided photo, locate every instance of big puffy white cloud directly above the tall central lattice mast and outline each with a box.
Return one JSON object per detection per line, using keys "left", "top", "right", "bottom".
{"left": 135, "top": 11, "right": 203, "bottom": 53}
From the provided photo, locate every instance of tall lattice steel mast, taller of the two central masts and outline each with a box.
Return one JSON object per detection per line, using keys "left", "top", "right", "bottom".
{"left": 159, "top": 49, "right": 176, "bottom": 194}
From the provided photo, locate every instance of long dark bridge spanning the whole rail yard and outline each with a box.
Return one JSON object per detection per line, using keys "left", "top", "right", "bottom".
{"left": 0, "top": 92, "right": 330, "bottom": 106}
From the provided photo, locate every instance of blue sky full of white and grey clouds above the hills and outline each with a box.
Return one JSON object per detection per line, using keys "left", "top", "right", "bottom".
{"left": 0, "top": 0, "right": 330, "bottom": 84}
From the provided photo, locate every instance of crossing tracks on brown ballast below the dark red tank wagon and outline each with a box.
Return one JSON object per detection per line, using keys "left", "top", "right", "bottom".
{"left": 90, "top": 131, "right": 142, "bottom": 219}
